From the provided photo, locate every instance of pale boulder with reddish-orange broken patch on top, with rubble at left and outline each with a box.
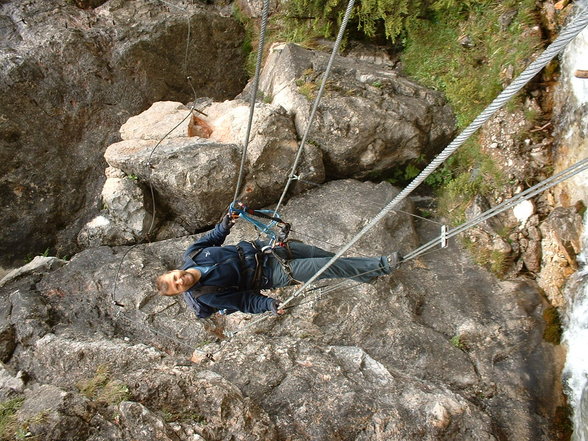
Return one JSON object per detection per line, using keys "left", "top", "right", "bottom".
{"left": 99, "top": 101, "right": 324, "bottom": 237}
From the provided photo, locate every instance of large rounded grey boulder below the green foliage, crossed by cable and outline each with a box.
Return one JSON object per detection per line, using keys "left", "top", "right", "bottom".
{"left": 260, "top": 44, "right": 455, "bottom": 178}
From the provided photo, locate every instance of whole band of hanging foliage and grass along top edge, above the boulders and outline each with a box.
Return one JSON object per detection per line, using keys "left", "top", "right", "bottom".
{"left": 233, "top": 0, "right": 541, "bottom": 127}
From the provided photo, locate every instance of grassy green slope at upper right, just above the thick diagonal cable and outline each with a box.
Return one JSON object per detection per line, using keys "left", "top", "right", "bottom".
{"left": 402, "top": 0, "right": 541, "bottom": 128}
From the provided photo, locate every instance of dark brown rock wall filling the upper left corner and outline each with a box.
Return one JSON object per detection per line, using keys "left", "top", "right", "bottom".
{"left": 0, "top": 0, "right": 246, "bottom": 263}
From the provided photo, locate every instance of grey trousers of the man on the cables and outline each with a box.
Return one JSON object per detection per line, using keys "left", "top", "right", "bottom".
{"left": 267, "top": 241, "right": 390, "bottom": 288}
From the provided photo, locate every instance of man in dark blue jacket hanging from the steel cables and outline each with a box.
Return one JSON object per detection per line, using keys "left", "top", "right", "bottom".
{"left": 156, "top": 213, "right": 402, "bottom": 318}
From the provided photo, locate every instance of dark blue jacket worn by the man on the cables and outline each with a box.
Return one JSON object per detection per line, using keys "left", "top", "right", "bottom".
{"left": 181, "top": 223, "right": 273, "bottom": 318}
